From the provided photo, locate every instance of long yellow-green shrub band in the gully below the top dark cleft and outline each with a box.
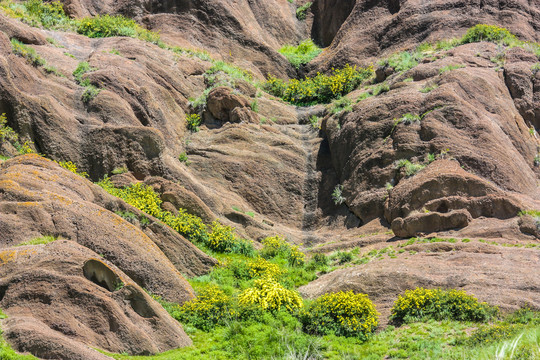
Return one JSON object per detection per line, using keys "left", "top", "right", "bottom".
{"left": 264, "top": 64, "right": 374, "bottom": 106}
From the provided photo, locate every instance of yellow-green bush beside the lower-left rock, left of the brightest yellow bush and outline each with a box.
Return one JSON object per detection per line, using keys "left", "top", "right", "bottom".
{"left": 171, "top": 285, "right": 237, "bottom": 331}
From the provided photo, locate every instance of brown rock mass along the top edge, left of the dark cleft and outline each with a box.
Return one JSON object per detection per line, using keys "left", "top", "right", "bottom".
{"left": 57, "top": 0, "right": 309, "bottom": 78}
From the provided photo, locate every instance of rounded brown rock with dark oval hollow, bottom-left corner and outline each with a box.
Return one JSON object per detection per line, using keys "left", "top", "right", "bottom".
{"left": 0, "top": 240, "right": 191, "bottom": 360}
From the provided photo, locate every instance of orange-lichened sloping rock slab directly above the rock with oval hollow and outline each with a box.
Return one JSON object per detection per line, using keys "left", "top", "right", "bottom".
{"left": 0, "top": 155, "right": 215, "bottom": 303}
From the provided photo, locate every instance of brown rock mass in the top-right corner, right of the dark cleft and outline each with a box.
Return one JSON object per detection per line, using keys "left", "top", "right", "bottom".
{"left": 311, "top": 0, "right": 540, "bottom": 70}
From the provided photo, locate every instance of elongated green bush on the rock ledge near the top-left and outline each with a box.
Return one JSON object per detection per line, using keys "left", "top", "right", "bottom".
{"left": 77, "top": 14, "right": 160, "bottom": 44}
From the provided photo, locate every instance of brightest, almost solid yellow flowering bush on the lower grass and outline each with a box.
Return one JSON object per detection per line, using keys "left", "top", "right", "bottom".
{"left": 238, "top": 277, "right": 304, "bottom": 312}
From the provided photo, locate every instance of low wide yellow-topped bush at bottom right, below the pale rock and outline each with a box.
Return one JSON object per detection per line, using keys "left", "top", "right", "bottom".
{"left": 390, "top": 288, "right": 498, "bottom": 324}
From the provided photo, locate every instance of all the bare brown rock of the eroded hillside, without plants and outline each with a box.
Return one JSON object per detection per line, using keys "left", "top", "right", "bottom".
{"left": 0, "top": 0, "right": 540, "bottom": 359}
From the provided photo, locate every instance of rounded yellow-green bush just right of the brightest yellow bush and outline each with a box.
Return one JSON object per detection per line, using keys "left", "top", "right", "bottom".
{"left": 300, "top": 291, "right": 379, "bottom": 340}
